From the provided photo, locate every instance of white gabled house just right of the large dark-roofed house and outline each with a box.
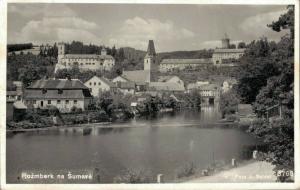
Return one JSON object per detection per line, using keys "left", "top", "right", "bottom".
{"left": 84, "top": 76, "right": 116, "bottom": 97}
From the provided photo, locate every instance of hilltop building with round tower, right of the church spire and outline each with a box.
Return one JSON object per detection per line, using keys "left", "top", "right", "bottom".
{"left": 212, "top": 34, "right": 245, "bottom": 66}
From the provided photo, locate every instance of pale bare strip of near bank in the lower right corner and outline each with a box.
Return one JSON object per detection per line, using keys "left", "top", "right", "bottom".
{"left": 181, "top": 160, "right": 276, "bottom": 183}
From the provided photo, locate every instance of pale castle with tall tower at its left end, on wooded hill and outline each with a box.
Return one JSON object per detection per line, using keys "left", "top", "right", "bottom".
{"left": 55, "top": 43, "right": 115, "bottom": 72}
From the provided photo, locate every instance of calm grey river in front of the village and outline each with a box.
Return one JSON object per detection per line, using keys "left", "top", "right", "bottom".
{"left": 6, "top": 107, "right": 258, "bottom": 183}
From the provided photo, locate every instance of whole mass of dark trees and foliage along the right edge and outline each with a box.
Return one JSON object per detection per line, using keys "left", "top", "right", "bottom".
{"left": 237, "top": 6, "right": 294, "bottom": 182}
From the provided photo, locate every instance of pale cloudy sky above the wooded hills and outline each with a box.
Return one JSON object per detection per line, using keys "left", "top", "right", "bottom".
{"left": 7, "top": 3, "right": 288, "bottom": 52}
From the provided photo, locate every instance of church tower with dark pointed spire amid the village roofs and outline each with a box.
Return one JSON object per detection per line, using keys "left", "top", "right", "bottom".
{"left": 144, "top": 40, "right": 158, "bottom": 82}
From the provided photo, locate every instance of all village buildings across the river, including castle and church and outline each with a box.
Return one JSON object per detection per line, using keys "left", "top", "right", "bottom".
{"left": 7, "top": 35, "right": 245, "bottom": 122}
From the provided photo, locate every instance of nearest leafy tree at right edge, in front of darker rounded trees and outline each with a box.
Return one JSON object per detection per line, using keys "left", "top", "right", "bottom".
{"left": 249, "top": 6, "right": 295, "bottom": 182}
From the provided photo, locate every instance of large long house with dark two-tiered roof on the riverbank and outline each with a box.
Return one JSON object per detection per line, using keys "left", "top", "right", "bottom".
{"left": 24, "top": 79, "right": 92, "bottom": 112}
